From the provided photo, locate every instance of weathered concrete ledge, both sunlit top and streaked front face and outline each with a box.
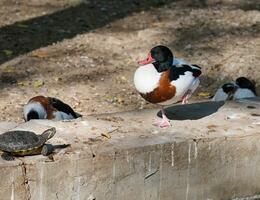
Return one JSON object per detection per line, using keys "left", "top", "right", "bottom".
{"left": 0, "top": 101, "right": 260, "bottom": 200}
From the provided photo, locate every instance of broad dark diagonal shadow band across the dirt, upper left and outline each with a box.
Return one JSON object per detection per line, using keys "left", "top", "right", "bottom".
{"left": 0, "top": 0, "right": 176, "bottom": 64}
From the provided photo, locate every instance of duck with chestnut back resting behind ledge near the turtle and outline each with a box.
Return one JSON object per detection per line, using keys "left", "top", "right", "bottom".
{"left": 23, "top": 96, "right": 79, "bottom": 121}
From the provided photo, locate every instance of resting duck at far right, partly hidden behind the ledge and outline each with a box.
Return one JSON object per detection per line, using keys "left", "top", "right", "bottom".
{"left": 212, "top": 77, "right": 256, "bottom": 101}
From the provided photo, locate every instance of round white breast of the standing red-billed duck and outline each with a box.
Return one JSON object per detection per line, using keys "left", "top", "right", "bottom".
{"left": 134, "top": 64, "right": 161, "bottom": 94}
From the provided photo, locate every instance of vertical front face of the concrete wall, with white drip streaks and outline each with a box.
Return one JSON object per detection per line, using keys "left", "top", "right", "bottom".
{"left": 0, "top": 136, "right": 260, "bottom": 200}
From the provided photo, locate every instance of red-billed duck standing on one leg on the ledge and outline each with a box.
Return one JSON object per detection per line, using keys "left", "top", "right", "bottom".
{"left": 134, "top": 45, "right": 201, "bottom": 128}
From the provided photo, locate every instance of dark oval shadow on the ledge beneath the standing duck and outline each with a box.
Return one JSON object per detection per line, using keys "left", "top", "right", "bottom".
{"left": 157, "top": 101, "right": 225, "bottom": 120}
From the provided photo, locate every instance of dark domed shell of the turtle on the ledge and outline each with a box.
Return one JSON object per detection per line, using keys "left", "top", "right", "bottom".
{"left": 0, "top": 131, "right": 46, "bottom": 152}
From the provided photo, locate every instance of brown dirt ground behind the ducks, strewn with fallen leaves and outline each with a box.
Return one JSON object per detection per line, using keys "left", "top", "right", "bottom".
{"left": 0, "top": 0, "right": 260, "bottom": 121}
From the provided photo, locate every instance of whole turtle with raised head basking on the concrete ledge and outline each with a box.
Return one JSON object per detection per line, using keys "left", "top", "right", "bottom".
{"left": 0, "top": 127, "right": 68, "bottom": 161}
